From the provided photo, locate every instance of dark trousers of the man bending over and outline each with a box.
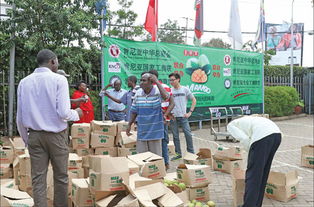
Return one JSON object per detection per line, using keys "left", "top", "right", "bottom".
{"left": 243, "top": 133, "right": 281, "bottom": 207}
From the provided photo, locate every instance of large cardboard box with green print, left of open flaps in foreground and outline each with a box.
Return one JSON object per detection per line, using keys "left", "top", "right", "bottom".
{"left": 89, "top": 155, "right": 129, "bottom": 191}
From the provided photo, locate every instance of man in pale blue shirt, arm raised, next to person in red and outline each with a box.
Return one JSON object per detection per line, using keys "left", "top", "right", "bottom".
{"left": 99, "top": 80, "right": 127, "bottom": 121}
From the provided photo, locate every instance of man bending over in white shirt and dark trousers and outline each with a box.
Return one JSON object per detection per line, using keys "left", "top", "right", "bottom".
{"left": 227, "top": 116, "right": 281, "bottom": 207}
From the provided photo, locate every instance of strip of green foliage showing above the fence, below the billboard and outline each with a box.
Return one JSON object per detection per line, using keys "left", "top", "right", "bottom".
{"left": 264, "top": 65, "right": 308, "bottom": 77}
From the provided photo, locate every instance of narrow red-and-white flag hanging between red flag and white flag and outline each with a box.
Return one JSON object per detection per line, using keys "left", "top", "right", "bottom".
{"left": 194, "top": 0, "right": 204, "bottom": 46}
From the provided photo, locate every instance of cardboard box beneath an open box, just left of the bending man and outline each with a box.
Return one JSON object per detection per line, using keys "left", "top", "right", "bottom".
{"left": 213, "top": 155, "right": 244, "bottom": 174}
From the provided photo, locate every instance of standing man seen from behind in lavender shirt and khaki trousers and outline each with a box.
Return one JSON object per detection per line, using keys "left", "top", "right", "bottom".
{"left": 16, "top": 49, "right": 82, "bottom": 207}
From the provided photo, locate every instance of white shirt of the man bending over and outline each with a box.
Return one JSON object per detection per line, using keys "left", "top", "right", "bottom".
{"left": 227, "top": 116, "right": 281, "bottom": 152}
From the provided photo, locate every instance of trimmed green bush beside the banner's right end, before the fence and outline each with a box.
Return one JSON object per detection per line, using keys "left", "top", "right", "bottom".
{"left": 265, "top": 86, "right": 299, "bottom": 116}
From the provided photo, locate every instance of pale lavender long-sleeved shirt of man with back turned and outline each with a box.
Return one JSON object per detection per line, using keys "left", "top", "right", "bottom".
{"left": 16, "top": 67, "right": 80, "bottom": 144}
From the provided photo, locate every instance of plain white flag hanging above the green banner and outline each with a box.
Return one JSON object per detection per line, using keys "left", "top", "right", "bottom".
{"left": 228, "top": 0, "right": 243, "bottom": 50}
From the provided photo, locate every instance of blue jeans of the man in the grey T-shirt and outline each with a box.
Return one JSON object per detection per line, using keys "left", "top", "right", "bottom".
{"left": 170, "top": 117, "right": 194, "bottom": 155}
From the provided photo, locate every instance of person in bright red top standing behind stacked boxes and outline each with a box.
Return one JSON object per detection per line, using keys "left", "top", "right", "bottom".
{"left": 71, "top": 81, "right": 94, "bottom": 123}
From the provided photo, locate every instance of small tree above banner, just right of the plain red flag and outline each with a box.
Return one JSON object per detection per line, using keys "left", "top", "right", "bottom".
{"left": 158, "top": 19, "right": 184, "bottom": 44}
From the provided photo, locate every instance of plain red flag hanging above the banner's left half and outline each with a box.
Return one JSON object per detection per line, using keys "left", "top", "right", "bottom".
{"left": 144, "top": 0, "right": 158, "bottom": 41}
